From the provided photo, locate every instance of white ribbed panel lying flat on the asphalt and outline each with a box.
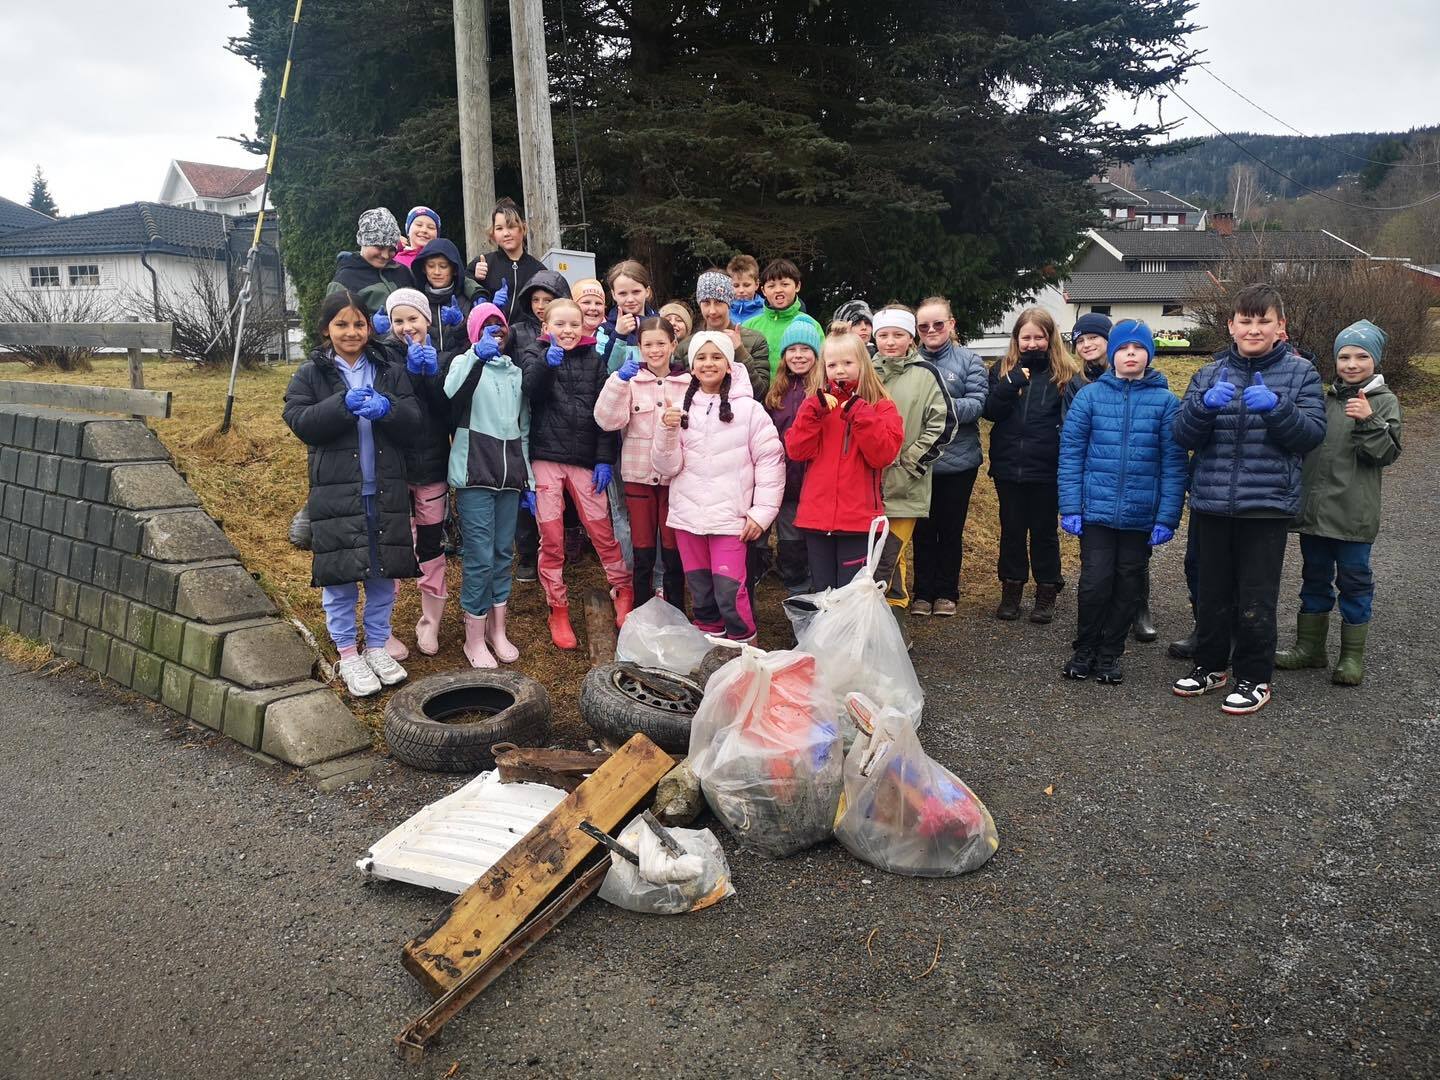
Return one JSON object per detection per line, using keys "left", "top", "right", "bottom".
{"left": 356, "top": 772, "right": 566, "bottom": 893}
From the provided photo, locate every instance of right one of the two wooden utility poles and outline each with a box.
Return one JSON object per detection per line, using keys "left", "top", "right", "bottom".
{"left": 510, "top": 0, "right": 560, "bottom": 259}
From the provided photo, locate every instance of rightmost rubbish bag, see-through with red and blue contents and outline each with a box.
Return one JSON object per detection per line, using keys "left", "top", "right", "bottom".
{"left": 835, "top": 708, "right": 999, "bottom": 877}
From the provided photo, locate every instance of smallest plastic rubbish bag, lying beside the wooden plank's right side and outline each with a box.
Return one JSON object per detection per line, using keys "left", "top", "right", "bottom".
{"left": 600, "top": 818, "right": 734, "bottom": 914}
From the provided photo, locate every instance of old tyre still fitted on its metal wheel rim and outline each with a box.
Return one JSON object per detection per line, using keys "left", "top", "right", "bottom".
{"left": 580, "top": 664, "right": 701, "bottom": 753}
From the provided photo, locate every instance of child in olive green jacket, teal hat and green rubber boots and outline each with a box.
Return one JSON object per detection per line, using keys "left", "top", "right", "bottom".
{"left": 1274, "top": 318, "right": 1401, "bottom": 687}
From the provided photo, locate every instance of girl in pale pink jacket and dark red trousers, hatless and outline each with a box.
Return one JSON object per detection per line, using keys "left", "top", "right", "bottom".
{"left": 595, "top": 315, "right": 690, "bottom": 611}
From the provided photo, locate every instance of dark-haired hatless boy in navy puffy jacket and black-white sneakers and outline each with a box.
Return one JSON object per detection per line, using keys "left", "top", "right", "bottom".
{"left": 1174, "top": 285, "right": 1325, "bottom": 716}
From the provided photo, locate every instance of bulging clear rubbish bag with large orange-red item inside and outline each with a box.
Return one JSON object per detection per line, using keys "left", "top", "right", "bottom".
{"left": 690, "top": 645, "right": 844, "bottom": 855}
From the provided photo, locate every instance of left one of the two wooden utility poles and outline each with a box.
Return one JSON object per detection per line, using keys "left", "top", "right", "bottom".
{"left": 455, "top": 0, "right": 495, "bottom": 259}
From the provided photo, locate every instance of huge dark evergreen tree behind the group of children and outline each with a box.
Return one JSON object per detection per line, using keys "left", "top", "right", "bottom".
{"left": 233, "top": 0, "right": 1194, "bottom": 331}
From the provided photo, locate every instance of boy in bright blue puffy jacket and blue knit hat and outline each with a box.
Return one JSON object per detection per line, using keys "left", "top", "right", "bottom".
{"left": 1058, "top": 318, "right": 1187, "bottom": 683}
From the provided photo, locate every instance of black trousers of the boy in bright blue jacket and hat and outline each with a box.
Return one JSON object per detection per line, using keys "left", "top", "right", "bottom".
{"left": 1074, "top": 521, "right": 1151, "bottom": 660}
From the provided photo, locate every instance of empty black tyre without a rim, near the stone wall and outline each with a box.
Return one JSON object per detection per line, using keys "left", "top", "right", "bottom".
{"left": 384, "top": 670, "right": 550, "bottom": 772}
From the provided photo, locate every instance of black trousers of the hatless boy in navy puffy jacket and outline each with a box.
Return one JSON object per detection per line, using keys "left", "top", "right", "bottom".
{"left": 1189, "top": 511, "right": 1289, "bottom": 683}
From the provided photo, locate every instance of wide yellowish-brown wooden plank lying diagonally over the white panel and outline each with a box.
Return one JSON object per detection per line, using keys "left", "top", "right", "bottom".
{"left": 402, "top": 734, "right": 674, "bottom": 996}
